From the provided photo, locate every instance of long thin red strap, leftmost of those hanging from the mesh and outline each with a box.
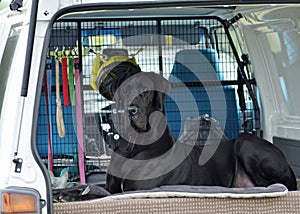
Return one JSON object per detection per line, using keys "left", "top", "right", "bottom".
{"left": 44, "top": 58, "right": 53, "bottom": 172}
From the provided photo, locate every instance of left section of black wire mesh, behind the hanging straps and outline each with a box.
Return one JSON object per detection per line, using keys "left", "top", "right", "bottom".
{"left": 37, "top": 22, "right": 78, "bottom": 178}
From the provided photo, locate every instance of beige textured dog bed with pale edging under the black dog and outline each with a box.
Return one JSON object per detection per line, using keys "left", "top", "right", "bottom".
{"left": 54, "top": 184, "right": 300, "bottom": 214}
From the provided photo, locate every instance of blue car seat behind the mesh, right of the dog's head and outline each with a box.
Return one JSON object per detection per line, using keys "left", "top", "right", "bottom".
{"left": 165, "top": 48, "right": 239, "bottom": 139}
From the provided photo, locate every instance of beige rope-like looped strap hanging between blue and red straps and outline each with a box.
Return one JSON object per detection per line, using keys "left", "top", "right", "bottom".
{"left": 55, "top": 58, "right": 66, "bottom": 137}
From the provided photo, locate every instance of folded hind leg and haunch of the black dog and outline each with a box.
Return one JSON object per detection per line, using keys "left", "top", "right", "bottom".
{"left": 234, "top": 133, "right": 297, "bottom": 190}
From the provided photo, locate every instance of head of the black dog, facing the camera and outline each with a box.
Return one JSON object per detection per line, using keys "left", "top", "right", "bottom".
{"left": 111, "top": 72, "right": 171, "bottom": 133}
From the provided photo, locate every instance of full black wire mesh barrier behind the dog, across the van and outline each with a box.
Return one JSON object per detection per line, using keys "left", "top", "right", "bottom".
{"left": 37, "top": 17, "right": 256, "bottom": 184}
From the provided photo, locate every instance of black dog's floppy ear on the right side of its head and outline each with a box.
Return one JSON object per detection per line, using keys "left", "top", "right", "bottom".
{"left": 147, "top": 72, "right": 171, "bottom": 111}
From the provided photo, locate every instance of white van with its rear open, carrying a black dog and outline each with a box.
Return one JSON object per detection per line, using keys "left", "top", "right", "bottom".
{"left": 0, "top": 0, "right": 300, "bottom": 213}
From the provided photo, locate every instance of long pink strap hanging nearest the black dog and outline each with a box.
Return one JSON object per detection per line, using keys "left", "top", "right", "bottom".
{"left": 74, "top": 58, "right": 85, "bottom": 184}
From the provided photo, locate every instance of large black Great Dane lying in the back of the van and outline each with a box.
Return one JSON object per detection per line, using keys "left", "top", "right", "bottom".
{"left": 101, "top": 72, "right": 297, "bottom": 193}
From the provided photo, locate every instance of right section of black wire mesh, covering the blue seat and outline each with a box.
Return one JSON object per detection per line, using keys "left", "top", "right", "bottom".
{"left": 161, "top": 18, "right": 240, "bottom": 138}
